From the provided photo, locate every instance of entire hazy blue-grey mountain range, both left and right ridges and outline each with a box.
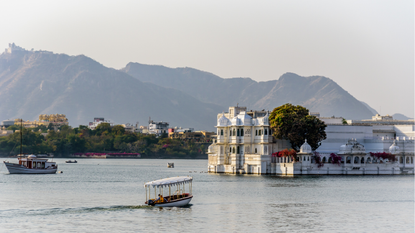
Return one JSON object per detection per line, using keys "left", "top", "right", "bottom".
{"left": 0, "top": 44, "right": 408, "bottom": 130}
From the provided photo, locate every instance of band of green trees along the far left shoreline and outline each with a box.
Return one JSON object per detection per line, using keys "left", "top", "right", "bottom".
{"left": 0, "top": 123, "right": 209, "bottom": 157}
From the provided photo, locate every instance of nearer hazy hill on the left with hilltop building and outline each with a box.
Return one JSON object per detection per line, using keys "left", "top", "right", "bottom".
{"left": 0, "top": 46, "right": 223, "bottom": 130}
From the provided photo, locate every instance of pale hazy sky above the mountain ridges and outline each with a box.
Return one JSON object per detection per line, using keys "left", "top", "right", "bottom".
{"left": 0, "top": 0, "right": 414, "bottom": 117}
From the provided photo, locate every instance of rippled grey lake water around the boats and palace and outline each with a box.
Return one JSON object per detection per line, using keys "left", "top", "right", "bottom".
{"left": 0, "top": 159, "right": 414, "bottom": 232}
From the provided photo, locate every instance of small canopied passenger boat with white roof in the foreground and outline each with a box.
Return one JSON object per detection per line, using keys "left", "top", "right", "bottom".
{"left": 144, "top": 176, "right": 193, "bottom": 207}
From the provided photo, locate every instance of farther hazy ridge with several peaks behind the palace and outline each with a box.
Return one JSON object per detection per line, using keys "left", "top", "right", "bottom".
{"left": 122, "top": 63, "right": 373, "bottom": 119}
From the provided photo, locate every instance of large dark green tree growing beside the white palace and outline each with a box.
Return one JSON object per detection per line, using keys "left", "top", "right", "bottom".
{"left": 269, "top": 104, "right": 327, "bottom": 151}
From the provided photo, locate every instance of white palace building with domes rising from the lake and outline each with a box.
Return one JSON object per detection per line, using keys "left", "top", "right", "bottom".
{"left": 208, "top": 106, "right": 415, "bottom": 175}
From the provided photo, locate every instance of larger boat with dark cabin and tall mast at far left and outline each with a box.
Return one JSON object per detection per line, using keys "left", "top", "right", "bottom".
{"left": 3, "top": 155, "right": 58, "bottom": 174}
